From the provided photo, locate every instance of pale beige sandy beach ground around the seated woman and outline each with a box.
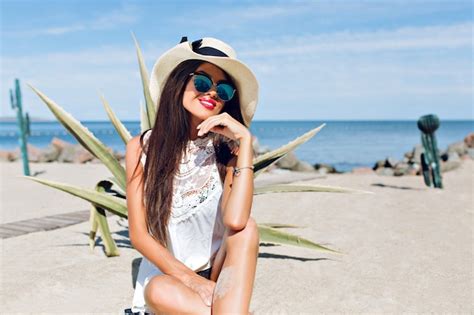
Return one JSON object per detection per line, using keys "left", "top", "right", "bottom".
{"left": 0, "top": 161, "right": 474, "bottom": 314}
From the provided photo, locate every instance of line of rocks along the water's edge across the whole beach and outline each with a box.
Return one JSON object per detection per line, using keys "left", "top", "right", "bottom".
{"left": 0, "top": 132, "right": 474, "bottom": 176}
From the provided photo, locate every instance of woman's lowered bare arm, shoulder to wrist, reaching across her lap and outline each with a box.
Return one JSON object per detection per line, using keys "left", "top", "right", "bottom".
{"left": 125, "top": 136, "right": 195, "bottom": 282}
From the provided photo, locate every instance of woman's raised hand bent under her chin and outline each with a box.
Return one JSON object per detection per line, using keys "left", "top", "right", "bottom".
{"left": 197, "top": 112, "right": 252, "bottom": 140}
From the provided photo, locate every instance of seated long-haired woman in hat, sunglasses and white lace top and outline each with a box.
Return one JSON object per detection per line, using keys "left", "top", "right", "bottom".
{"left": 126, "top": 37, "right": 259, "bottom": 314}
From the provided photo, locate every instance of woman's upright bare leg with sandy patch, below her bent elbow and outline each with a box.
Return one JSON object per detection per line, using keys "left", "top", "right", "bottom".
{"left": 212, "top": 217, "right": 259, "bottom": 314}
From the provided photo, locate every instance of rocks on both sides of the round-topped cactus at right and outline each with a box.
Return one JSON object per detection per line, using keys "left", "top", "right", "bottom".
{"left": 360, "top": 133, "right": 474, "bottom": 176}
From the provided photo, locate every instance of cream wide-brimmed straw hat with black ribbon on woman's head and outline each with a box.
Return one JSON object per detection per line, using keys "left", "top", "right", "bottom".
{"left": 149, "top": 37, "right": 258, "bottom": 127}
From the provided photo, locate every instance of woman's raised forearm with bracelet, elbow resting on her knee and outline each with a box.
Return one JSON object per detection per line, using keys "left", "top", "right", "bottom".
{"left": 221, "top": 132, "right": 253, "bottom": 230}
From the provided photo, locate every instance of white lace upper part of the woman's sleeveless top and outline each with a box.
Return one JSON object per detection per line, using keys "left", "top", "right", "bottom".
{"left": 141, "top": 131, "right": 222, "bottom": 224}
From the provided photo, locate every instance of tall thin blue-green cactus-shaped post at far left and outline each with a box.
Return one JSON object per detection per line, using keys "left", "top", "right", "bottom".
{"left": 10, "top": 79, "right": 30, "bottom": 176}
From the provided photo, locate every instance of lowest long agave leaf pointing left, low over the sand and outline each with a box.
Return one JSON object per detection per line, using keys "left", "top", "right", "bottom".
{"left": 22, "top": 176, "right": 128, "bottom": 218}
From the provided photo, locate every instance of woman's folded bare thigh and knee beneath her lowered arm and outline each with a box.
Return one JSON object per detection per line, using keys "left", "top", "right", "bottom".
{"left": 144, "top": 275, "right": 211, "bottom": 314}
